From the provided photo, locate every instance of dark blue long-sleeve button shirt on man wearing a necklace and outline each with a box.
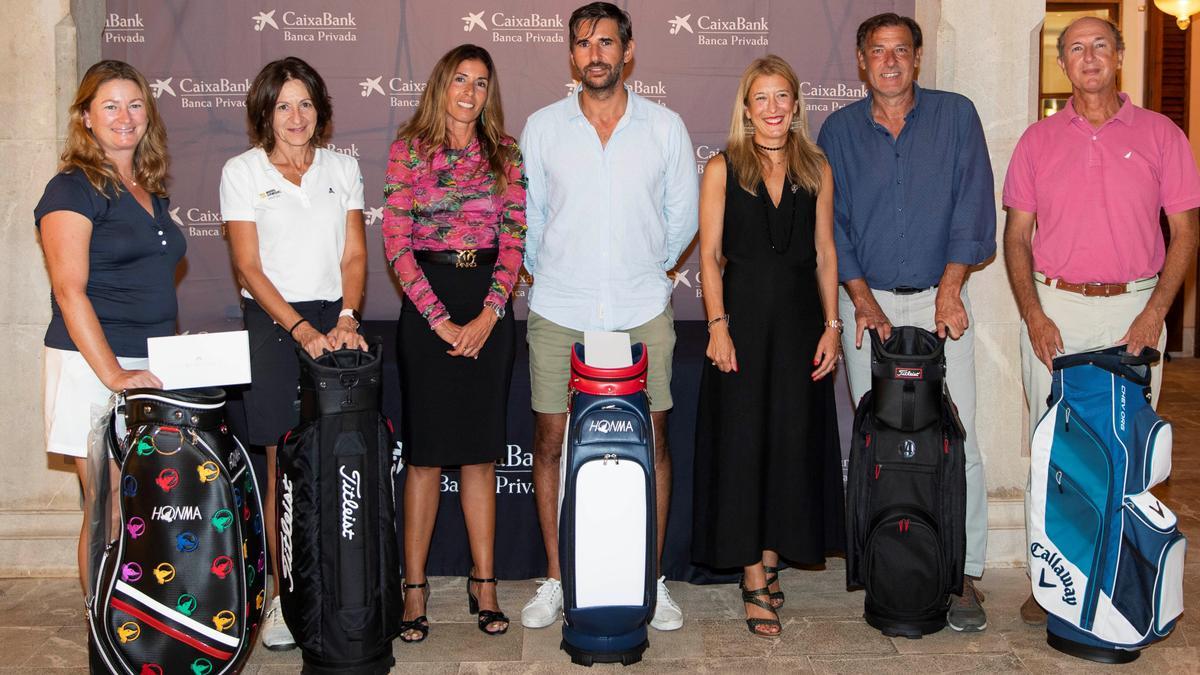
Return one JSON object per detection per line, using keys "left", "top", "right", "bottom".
{"left": 817, "top": 84, "right": 996, "bottom": 289}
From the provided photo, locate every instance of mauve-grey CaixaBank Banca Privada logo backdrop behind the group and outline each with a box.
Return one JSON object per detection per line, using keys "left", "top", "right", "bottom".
{"left": 103, "top": 0, "right": 914, "bottom": 578}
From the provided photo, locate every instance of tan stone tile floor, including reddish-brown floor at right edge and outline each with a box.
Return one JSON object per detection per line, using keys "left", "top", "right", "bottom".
{"left": 7, "top": 359, "right": 1200, "bottom": 675}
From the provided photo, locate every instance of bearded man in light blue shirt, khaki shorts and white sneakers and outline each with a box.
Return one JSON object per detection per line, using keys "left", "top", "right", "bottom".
{"left": 521, "top": 2, "right": 698, "bottom": 631}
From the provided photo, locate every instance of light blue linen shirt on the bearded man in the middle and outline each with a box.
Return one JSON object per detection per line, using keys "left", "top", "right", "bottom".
{"left": 521, "top": 85, "right": 698, "bottom": 330}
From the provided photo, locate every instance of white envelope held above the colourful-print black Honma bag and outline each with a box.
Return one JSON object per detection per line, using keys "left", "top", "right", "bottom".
{"left": 146, "top": 330, "right": 250, "bottom": 389}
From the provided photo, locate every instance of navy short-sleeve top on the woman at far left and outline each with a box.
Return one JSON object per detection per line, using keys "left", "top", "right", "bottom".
{"left": 34, "top": 171, "right": 187, "bottom": 357}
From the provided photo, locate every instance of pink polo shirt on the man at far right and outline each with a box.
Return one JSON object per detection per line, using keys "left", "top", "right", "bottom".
{"left": 1004, "top": 94, "right": 1200, "bottom": 283}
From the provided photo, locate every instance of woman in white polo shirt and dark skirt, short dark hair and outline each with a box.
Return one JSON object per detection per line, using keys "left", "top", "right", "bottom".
{"left": 221, "top": 56, "right": 366, "bottom": 650}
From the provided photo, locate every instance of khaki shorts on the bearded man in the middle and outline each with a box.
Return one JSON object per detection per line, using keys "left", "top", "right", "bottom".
{"left": 526, "top": 303, "right": 674, "bottom": 413}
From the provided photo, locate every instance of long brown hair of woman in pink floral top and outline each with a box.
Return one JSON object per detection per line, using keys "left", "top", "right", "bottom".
{"left": 396, "top": 44, "right": 516, "bottom": 195}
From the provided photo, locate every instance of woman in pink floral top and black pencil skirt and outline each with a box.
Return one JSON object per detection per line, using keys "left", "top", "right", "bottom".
{"left": 383, "top": 44, "right": 526, "bottom": 643}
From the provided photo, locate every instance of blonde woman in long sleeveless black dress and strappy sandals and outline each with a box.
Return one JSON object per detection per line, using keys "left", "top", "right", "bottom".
{"left": 692, "top": 55, "right": 845, "bottom": 637}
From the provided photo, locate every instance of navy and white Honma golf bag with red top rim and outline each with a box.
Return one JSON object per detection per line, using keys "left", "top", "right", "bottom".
{"left": 558, "top": 344, "right": 656, "bottom": 665}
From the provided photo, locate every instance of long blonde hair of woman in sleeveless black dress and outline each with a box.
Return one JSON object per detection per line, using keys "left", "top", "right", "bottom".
{"left": 726, "top": 54, "right": 826, "bottom": 195}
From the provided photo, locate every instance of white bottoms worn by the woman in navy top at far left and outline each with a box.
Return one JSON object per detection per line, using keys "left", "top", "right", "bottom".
{"left": 42, "top": 347, "right": 150, "bottom": 458}
